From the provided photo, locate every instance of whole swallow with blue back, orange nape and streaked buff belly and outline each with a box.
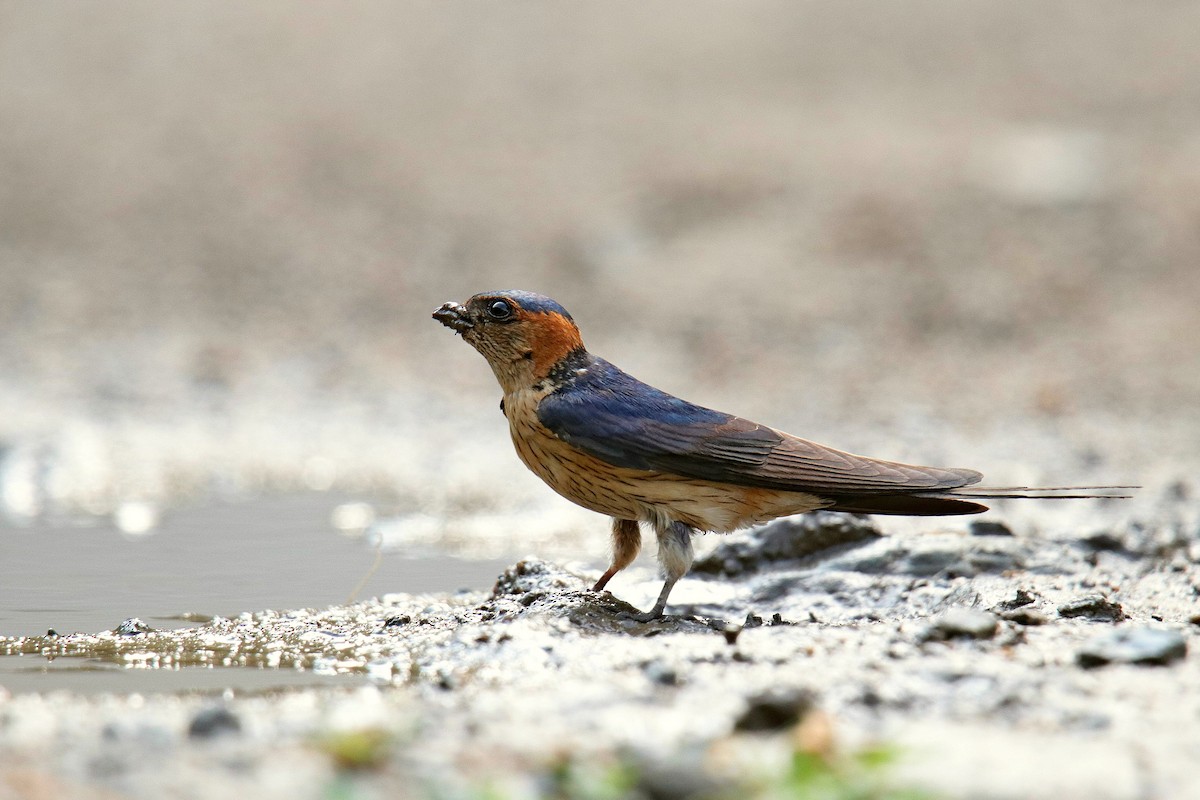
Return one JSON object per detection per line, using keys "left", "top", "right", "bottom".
{"left": 433, "top": 290, "right": 1136, "bottom": 621}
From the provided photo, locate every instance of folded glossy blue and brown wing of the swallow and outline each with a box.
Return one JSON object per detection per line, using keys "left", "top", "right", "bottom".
{"left": 538, "top": 359, "right": 980, "bottom": 495}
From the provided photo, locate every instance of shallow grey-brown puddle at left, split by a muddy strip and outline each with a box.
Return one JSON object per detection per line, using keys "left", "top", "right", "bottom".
{"left": 0, "top": 494, "right": 510, "bottom": 692}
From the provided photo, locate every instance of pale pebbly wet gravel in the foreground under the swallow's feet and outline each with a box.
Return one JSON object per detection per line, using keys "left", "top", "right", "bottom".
{"left": 0, "top": 515, "right": 1200, "bottom": 798}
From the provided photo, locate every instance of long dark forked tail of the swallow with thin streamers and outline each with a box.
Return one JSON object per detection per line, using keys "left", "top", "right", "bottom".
{"left": 827, "top": 486, "right": 1141, "bottom": 517}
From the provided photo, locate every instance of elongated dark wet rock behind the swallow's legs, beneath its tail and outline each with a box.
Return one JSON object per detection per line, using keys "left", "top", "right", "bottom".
{"left": 691, "top": 511, "right": 882, "bottom": 576}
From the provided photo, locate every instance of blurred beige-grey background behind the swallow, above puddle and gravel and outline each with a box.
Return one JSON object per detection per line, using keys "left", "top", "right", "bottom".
{"left": 0, "top": 1, "right": 1200, "bottom": 627}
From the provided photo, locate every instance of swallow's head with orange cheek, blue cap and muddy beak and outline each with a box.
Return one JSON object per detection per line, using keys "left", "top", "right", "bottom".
{"left": 433, "top": 289, "right": 583, "bottom": 393}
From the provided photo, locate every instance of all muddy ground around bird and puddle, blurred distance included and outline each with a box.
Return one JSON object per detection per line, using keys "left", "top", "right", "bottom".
{"left": 0, "top": 2, "right": 1200, "bottom": 798}
